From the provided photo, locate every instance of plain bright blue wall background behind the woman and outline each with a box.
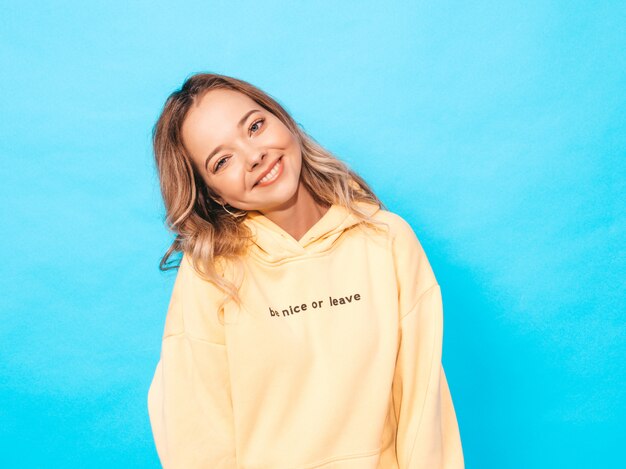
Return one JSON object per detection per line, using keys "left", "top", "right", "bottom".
{"left": 0, "top": 0, "right": 626, "bottom": 469}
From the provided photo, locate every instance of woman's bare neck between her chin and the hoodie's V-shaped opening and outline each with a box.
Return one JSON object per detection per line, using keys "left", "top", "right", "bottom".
{"left": 261, "top": 183, "right": 330, "bottom": 241}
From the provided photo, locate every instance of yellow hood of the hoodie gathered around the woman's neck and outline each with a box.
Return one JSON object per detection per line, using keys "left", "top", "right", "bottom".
{"left": 243, "top": 201, "right": 380, "bottom": 264}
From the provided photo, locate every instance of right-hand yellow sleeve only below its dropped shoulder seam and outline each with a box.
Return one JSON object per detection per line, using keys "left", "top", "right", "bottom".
{"left": 392, "top": 285, "right": 464, "bottom": 469}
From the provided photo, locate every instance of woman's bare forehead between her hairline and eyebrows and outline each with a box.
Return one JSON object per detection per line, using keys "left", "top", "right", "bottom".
{"left": 181, "top": 89, "right": 262, "bottom": 156}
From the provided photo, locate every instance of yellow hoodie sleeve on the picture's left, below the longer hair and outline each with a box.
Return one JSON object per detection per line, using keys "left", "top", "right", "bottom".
{"left": 148, "top": 257, "right": 237, "bottom": 469}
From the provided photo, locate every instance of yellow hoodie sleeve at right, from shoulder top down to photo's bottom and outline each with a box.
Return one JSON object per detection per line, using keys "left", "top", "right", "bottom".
{"left": 392, "top": 216, "right": 465, "bottom": 469}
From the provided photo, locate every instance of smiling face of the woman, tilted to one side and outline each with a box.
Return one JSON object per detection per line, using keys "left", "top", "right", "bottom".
{"left": 181, "top": 89, "right": 302, "bottom": 212}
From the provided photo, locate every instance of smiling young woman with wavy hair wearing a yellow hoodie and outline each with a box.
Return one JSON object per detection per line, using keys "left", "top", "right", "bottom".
{"left": 148, "top": 74, "right": 464, "bottom": 469}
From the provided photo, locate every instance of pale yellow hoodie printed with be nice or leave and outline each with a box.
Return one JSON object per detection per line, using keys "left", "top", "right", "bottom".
{"left": 148, "top": 202, "right": 464, "bottom": 469}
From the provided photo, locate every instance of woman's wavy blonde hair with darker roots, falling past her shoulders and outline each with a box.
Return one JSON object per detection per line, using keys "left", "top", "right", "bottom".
{"left": 152, "top": 73, "right": 385, "bottom": 308}
